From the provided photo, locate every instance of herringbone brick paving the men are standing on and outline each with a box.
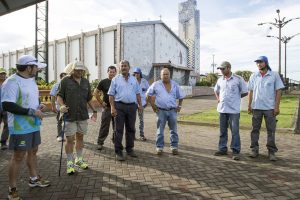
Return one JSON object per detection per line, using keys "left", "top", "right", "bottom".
{"left": 0, "top": 97, "right": 300, "bottom": 200}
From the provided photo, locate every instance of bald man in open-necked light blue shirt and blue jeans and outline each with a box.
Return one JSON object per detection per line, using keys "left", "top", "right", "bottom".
{"left": 147, "top": 68, "right": 185, "bottom": 155}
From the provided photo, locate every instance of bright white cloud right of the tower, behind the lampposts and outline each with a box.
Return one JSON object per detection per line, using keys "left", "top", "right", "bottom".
{"left": 200, "top": 2, "right": 300, "bottom": 80}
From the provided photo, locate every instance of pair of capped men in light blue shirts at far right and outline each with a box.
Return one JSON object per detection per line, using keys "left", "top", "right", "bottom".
{"left": 214, "top": 56, "right": 284, "bottom": 161}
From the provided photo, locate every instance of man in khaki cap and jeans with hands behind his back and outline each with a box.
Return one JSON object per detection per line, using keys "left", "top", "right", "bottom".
{"left": 214, "top": 61, "right": 248, "bottom": 160}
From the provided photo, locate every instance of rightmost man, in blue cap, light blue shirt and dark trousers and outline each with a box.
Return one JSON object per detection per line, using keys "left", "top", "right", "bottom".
{"left": 248, "top": 56, "right": 284, "bottom": 161}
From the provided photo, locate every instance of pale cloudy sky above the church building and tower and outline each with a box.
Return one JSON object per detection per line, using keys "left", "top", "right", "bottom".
{"left": 0, "top": 0, "right": 300, "bottom": 80}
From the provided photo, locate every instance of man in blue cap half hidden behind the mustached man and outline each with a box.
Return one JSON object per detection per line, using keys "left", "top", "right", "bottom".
{"left": 133, "top": 67, "right": 149, "bottom": 141}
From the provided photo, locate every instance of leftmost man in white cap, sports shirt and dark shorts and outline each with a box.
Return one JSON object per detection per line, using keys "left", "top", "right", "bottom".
{"left": 1, "top": 55, "right": 50, "bottom": 199}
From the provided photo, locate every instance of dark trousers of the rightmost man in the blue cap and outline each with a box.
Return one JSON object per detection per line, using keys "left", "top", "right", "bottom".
{"left": 250, "top": 110, "right": 278, "bottom": 153}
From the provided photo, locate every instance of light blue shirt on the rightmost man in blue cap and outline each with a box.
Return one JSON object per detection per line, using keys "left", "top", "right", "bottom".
{"left": 248, "top": 70, "right": 284, "bottom": 110}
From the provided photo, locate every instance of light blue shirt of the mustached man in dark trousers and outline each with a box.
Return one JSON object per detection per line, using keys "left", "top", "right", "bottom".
{"left": 107, "top": 74, "right": 141, "bottom": 103}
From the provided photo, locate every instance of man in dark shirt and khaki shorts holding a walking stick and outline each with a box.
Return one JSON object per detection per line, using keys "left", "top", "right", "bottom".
{"left": 57, "top": 62, "right": 97, "bottom": 174}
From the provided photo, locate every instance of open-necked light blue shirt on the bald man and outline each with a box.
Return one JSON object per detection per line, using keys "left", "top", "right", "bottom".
{"left": 147, "top": 80, "right": 185, "bottom": 109}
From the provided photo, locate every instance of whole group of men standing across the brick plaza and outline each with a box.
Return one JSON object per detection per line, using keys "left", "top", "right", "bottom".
{"left": 0, "top": 55, "right": 283, "bottom": 199}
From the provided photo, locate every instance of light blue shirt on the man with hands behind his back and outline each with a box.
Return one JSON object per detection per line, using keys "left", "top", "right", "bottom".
{"left": 214, "top": 74, "right": 248, "bottom": 114}
